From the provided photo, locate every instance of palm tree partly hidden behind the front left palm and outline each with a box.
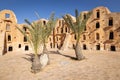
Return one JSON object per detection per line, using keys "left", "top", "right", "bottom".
{"left": 41, "top": 13, "right": 57, "bottom": 64}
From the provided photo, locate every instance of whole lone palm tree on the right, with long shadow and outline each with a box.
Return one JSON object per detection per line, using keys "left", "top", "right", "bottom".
{"left": 63, "top": 10, "right": 91, "bottom": 60}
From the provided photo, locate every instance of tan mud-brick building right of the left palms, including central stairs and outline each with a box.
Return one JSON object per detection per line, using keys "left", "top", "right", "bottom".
{"left": 50, "top": 6, "right": 120, "bottom": 51}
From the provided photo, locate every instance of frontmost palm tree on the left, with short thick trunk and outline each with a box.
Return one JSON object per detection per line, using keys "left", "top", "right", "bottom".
{"left": 17, "top": 19, "right": 42, "bottom": 73}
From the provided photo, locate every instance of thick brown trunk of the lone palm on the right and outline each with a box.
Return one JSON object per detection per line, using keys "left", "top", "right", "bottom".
{"left": 75, "top": 41, "right": 85, "bottom": 60}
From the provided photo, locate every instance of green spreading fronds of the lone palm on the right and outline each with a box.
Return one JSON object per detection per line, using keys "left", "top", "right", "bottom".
{"left": 62, "top": 9, "right": 92, "bottom": 40}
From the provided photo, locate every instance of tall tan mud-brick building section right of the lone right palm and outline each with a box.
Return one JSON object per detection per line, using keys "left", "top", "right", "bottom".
{"left": 81, "top": 7, "right": 120, "bottom": 51}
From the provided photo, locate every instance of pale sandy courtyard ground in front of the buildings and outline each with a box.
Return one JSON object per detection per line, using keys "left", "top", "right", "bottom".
{"left": 0, "top": 50, "right": 120, "bottom": 80}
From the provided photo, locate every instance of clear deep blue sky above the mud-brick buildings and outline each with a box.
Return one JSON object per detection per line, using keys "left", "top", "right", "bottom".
{"left": 0, "top": 0, "right": 120, "bottom": 23}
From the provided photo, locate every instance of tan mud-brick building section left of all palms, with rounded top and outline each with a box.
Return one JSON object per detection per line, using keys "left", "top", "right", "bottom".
{"left": 0, "top": 10, "right": 32, "bottom": 55}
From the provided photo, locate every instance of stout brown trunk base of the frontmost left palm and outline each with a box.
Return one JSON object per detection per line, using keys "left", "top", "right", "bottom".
{"left": 31, "top": 55, "right": 41, "bottom": 73}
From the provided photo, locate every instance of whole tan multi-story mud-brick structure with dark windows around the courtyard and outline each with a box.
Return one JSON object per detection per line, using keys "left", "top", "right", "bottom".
{"left": 0, "top": 7, "right": 120, "bottom": 55}
